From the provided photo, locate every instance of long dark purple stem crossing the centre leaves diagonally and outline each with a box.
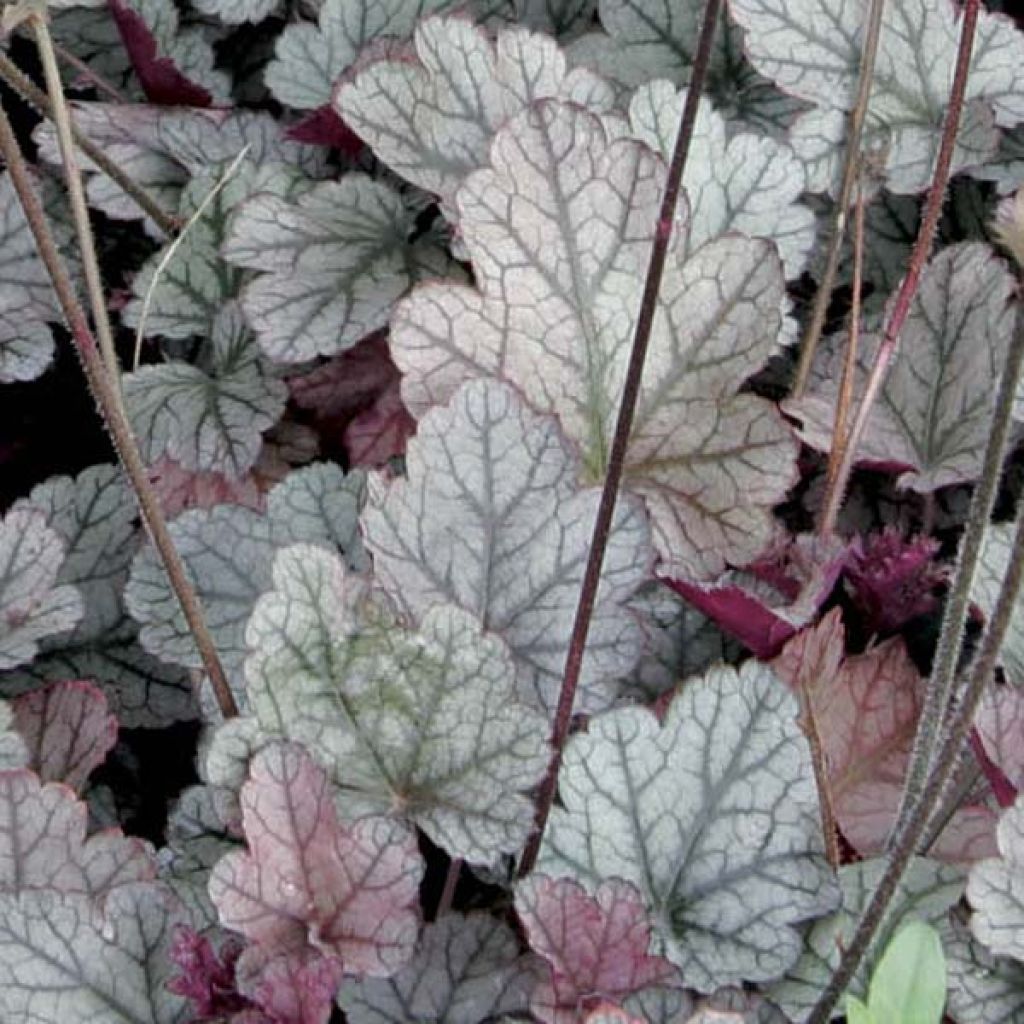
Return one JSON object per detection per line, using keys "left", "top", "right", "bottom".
{"left": 518, "top": 0, "right": 722, "bottom": 878}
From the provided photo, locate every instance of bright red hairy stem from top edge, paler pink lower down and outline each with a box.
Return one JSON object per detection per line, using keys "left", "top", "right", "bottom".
{"left": 825, "top": 0, "right": 980, "bottom": 536}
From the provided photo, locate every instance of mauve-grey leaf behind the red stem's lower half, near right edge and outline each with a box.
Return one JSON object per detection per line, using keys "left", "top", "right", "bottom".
{"left": 785, "top": 244, "right": 1014, "bottom": 493}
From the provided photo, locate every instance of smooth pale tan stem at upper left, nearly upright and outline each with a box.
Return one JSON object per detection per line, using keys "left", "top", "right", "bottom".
{"left": 29, "top": 14, "right": 121, "bottom": 387}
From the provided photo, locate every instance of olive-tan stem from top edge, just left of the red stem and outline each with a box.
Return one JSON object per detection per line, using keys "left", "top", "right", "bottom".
{"left": 793, "top": 0, "right": 885, "bottom": 398}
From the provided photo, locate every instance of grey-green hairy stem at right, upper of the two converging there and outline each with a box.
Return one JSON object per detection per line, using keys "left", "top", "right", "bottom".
{"left": 890, "top": 299, "right": 1024, "bottom": 845}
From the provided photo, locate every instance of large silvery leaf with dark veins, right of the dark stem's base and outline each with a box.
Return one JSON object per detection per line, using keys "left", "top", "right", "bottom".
{"left": 538, "top": 662, "right": 836, "bottom": 991}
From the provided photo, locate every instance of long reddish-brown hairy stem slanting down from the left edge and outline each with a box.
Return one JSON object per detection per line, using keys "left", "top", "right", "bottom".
{"left": 0, "top": 96, "right": 238, "bottom": 718}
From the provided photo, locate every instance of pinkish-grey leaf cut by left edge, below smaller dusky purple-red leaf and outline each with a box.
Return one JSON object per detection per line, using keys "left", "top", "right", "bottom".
{"left": 0, "top": 769, "right": 157, "bottom": 896}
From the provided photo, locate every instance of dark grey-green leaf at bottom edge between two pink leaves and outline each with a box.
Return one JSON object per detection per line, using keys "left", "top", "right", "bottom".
{"left": 338, "top": 913, "right": 540, "bottom": 1024}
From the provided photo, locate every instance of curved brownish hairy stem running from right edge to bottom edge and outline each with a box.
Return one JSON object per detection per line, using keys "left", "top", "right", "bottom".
{"left": 807, "top": 491, "right": 1024, "bottom": 1024}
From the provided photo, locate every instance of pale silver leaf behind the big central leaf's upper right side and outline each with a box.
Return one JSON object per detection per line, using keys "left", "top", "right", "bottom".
{"left": 630, "top": 81, "right": 815, "bottom": 280}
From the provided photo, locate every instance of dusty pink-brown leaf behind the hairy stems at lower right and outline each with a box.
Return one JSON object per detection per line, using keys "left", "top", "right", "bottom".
{"left": 772, "top": 609, "right": 995, "bottom": 861}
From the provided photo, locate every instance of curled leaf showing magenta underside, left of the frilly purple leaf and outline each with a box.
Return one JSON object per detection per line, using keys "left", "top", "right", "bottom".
{"left": 665, "top": 535, "right": 847, "bottom": 658}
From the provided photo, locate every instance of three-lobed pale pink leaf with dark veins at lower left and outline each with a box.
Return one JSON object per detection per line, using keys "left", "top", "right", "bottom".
{"left": 210, "top": 743, "right": 423, "bottom": 977}
